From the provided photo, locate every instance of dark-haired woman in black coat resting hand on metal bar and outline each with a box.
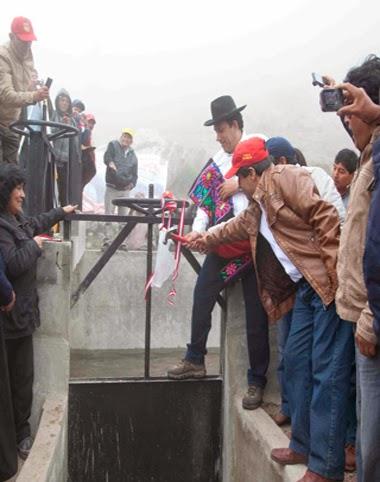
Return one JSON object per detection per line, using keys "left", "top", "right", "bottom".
{"left": 0, "top": 164, "right": 75, "bottom": 458}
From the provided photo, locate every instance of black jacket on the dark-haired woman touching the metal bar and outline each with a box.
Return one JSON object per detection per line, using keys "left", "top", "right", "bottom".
{"left": 0, "top": 208, "right": 65, "bottom": 339}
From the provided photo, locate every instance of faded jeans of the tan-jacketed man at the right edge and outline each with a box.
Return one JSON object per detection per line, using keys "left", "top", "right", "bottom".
{"left": 356, "top": 349, "right": 380, "bottom": 482}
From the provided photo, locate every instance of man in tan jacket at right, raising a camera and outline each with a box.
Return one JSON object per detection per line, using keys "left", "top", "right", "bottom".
{"left": 336, "top": 56, "right": 380, "bottom": 482}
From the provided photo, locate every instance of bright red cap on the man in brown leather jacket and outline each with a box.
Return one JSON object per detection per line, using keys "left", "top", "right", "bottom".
{"left": 224, "top": 137, "right": 269, "bottom": 179}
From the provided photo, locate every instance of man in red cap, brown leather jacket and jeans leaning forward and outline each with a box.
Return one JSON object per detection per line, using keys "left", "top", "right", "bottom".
{"left": 191, "top": 139, "right": 354, "bottom": 482}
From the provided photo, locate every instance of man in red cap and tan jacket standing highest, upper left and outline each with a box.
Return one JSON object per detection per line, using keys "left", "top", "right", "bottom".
{"left": 0, "top": 17, "right": 49, "bottom": 164}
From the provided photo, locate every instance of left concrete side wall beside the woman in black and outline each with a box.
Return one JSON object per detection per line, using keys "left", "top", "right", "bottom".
{"left": 17, "top": 242, "right": 71, "bottom": 482}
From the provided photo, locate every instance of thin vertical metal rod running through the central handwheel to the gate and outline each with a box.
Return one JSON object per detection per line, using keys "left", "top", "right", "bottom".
{"left": 144, "top": 184, "right": 154, "bottom": 378}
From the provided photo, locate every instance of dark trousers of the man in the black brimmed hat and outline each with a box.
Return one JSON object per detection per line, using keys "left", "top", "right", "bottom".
{"left": 185, "top": 254, "right": 269, "bottom": 387}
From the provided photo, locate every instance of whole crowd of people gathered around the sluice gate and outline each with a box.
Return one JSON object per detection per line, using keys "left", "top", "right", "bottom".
{"left": 0, "top": 11, "right": 380, "bottom": 482}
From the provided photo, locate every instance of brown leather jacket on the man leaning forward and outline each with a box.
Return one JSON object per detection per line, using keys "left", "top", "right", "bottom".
{"left": 205, "top": 165, "right": 340, "bottom": 321}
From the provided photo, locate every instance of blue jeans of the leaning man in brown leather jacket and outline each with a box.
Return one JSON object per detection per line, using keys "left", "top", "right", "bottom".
{"left": 284, "top": 281, "right": 354, "bottom": 480}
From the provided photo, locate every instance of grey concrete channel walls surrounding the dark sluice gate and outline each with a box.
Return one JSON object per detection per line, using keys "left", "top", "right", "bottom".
{"left": 18, "top": 243, "right": 305, "bottom": 482}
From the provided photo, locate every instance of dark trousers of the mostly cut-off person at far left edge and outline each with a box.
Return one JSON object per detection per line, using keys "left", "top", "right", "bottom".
{"left": 0, "top": 323, "right": 17, "bottom": 481}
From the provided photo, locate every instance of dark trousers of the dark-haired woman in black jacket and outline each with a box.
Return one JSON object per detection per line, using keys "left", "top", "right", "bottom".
{"left": 5, "top": 335, "right": 34, "bottom": 443}
